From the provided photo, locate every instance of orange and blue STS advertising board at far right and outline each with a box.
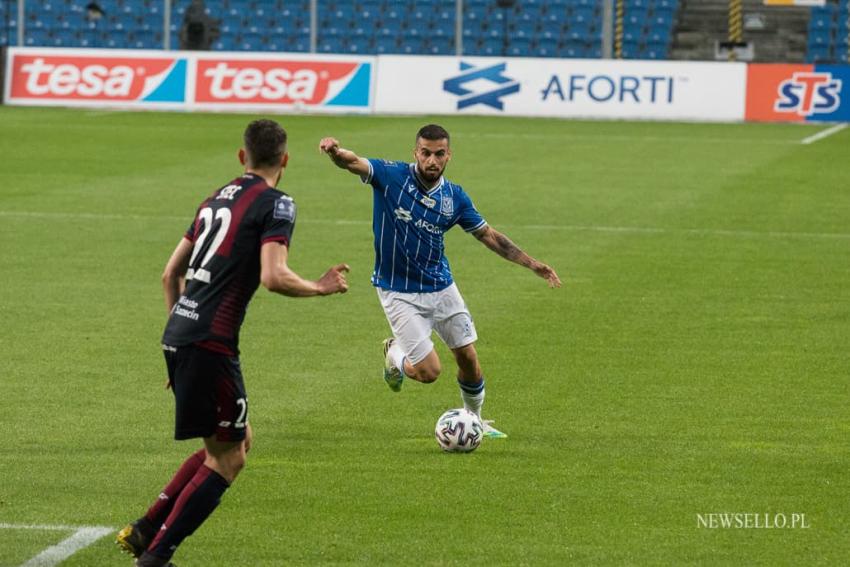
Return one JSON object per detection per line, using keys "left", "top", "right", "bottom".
{"left": 746, "top": 64, "right": 850, "bottom": 122}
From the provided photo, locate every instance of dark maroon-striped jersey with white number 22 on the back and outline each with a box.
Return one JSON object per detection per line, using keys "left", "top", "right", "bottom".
{"left": 162, "top": 173, "right": 295, "bottom": 355}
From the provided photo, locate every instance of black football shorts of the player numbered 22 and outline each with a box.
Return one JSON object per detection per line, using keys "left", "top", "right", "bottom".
{"left": 162, "top": 345, "right": 248, "bottom": 441}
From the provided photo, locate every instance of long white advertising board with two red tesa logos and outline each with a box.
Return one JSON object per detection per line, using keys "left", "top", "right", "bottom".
{"left": 4, "top": 48, "right": 375, "bottom": 112}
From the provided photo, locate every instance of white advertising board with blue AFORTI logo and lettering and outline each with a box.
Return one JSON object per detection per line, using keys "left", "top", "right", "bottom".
{"left": 375, "top": 56, "right": 747, "bottom": 121}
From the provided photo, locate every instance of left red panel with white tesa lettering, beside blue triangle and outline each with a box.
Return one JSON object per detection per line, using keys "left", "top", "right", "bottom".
{"left": 10, "top": 55, "right": 174, "bottom": 100}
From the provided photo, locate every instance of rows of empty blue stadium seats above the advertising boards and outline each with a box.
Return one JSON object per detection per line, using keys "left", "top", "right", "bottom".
{"left": 8, "top": 0, "right": 688, "bottom": 58}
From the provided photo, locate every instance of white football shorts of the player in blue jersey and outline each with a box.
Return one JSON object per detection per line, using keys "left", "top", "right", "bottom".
{"left": 377, "top": 284, "right": 478, "bottom": 364}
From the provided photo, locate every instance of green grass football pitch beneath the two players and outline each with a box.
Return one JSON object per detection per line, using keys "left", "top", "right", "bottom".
{"left": 0, "top": 107, "right": 850, "bottom": 567}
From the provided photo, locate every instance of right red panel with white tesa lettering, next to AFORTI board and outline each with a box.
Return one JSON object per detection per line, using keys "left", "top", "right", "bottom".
{"left": 195, "top": 59, "right": 359, "bottom": 105}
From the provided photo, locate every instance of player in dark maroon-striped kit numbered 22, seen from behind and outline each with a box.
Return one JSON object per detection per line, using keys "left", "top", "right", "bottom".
{"left": 117, "top": 120, "right": 348, "bottom": 567}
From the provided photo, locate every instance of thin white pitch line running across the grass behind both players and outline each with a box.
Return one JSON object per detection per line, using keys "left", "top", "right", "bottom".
{"left": 0, "top": 210, "right": 850, "bottom": 240}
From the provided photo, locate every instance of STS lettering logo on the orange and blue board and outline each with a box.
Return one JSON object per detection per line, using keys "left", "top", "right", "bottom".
{"left": 773, "top": 71, "right": 841, "bottom": 116}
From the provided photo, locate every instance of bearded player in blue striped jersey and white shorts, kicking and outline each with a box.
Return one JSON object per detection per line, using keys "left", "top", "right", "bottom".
{"left": 319, "top": 124, "right": 561, "bottom": 438}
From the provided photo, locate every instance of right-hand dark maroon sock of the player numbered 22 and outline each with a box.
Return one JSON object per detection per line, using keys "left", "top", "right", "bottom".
{"left": 146, "top": 465, "right": 230, "bottom": 559}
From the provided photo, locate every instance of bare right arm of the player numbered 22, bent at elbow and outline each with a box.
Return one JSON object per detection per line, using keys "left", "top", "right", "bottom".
{"left": 260, "top": 242, "right": 348, "bottom": 297}
